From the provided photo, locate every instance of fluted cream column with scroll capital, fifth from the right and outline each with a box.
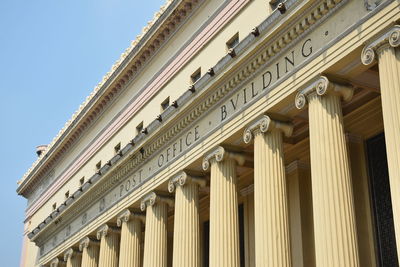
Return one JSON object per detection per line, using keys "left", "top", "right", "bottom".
{"left": 168, "top": 171, "right": 206, "bottom": 267}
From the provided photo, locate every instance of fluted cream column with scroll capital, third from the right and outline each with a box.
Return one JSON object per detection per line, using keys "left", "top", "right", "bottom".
{"left": 244, "top": 115, "right": 293, "bottom": 267}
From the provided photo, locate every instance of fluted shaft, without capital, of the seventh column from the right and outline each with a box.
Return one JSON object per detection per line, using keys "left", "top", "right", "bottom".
{"left": 119, "top": 219, "right": 142, "bottom": 267}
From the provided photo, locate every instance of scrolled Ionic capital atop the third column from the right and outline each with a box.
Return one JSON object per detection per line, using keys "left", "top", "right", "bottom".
{"left": 243, "top": 115, "right": 293, "bottom": 144}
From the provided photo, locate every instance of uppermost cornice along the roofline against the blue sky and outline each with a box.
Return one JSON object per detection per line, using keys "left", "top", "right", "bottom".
{"left": 17, "top": 0, "right": 203, "bottom": 197}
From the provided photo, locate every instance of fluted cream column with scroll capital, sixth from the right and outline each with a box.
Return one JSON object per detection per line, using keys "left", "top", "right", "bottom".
{"left": 140, "top": 192, "right": 173, "bottom": 267}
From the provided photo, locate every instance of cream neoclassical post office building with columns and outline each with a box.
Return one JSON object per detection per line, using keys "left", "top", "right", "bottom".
{"left": 17, "top": 0, "right": 400, "bottom": 267}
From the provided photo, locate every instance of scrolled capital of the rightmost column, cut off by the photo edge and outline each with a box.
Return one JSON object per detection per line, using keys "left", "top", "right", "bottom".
{"left": 361, "top": 25, "right": 400, "bottom": 66}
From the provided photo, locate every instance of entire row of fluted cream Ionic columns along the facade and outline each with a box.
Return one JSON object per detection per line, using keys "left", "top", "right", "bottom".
{"left": 51, "top": 26, "right": 400, "bottom": 267}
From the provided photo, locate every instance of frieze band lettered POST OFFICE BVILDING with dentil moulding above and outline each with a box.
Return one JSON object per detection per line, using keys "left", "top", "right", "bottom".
{"left": 34, "top": 0, "right": 376, "bottom": 260}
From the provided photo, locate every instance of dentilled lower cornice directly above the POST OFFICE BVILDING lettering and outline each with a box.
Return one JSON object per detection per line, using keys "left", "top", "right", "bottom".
{"left": 30, "top": 0, "right": 347, "bottom": 251}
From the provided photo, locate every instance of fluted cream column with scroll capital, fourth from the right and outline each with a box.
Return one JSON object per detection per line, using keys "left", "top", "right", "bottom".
{"left": 203, "top": 146, "right": 245, "bottom": 267}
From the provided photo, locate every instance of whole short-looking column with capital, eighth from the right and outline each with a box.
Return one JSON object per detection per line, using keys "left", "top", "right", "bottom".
{"left": 97, "top": 224, "right": 120, "bottom": 267}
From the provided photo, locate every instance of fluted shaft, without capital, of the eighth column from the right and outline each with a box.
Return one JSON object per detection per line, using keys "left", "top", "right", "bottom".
{"left": 99, "top": 232, "right": 119, "bottom": 267}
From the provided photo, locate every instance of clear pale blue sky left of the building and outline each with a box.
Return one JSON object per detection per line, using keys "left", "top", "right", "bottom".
{"left": 0, "top": 0, "right": 165, "bottom": 267}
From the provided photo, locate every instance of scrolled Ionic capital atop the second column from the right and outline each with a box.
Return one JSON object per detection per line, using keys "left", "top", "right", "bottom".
{"left": 295, "top": 76, "right": 354, "bottom": 109}
